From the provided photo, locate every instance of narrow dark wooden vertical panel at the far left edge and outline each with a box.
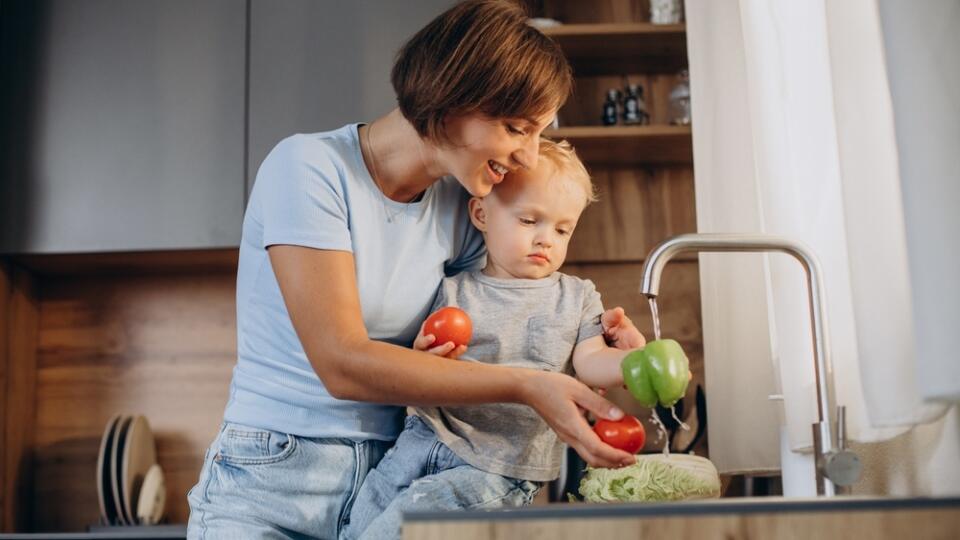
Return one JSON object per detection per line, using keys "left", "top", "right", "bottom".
{"left": 0, "top": 262, "right": 37, "bottom": 532}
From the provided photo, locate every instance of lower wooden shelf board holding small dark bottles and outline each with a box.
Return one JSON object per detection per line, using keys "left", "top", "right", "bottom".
{"left": 544, "top": 125, "right": 693, "bottom": 165}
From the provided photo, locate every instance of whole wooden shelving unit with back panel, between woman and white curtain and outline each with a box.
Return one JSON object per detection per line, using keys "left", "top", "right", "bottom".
{"left": 526, "top": 0, "right": 708, "bottom": 468}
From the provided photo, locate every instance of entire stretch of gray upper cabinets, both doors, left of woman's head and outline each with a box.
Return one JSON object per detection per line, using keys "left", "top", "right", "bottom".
{"left": 0, "top": 0, "right": 455, "bottom": 253}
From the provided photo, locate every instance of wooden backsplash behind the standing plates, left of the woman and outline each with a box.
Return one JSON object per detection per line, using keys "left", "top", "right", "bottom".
{"left": 31, "top": 272, "right": 236, "bottom": 530}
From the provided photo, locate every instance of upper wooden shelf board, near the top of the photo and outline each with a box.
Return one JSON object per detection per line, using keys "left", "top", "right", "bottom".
{"left": 542, "top": 23, "right": 687, "bottom": 76}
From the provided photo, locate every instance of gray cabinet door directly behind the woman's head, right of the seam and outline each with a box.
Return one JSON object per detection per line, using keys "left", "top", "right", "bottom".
{"left": 247, "top": 0, "right": 456, "bottom": 197}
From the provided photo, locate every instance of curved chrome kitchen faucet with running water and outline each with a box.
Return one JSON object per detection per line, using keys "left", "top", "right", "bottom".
{"left": 640, "top": 233, "right": 862, "bottom": 496}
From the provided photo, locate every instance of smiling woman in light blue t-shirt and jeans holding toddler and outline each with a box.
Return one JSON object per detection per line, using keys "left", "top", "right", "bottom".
{"left": 188, "top": 0, "right": 643, "bottom": 538}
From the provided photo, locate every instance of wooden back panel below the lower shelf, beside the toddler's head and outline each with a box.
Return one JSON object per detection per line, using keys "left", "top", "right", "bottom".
{"left": 567, "top": 167, "right": 697, "bottom": 262}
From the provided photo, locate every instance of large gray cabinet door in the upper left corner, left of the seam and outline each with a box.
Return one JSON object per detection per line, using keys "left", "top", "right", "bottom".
{"left": 0, "top": 0, "right": 248, "bottom": 253}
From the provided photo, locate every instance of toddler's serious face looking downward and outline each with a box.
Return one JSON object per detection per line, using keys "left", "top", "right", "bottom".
{"left": 470, "top": 159, "right": 587, "bottom": 279}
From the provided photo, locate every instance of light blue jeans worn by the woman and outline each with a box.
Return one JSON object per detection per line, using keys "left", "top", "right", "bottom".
{"left": 187, "top": 422, "right": 392, "bottom": 540}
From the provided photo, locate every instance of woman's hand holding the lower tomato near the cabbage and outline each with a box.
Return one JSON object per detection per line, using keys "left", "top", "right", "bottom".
{"left": 523, "top": 371, "right": 636, "bottom": 468}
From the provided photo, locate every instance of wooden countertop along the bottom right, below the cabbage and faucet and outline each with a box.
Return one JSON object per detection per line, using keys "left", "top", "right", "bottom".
{"left": 403, "top": 497, "right": 960, "bottom": 540}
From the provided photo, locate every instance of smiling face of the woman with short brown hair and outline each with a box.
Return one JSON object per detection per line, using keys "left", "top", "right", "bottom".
{"left": 438, "top": 111, "right": 556, "bottom": 197}
